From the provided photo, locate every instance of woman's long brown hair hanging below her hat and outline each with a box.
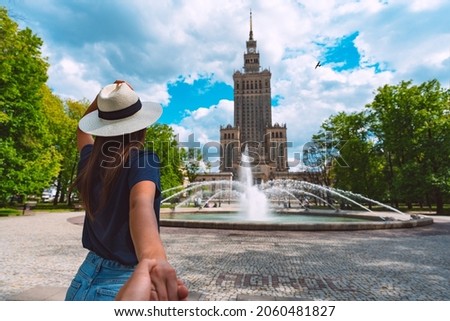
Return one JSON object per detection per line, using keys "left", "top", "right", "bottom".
{"left": 74, "top": 128, "right": 146, "bottom": 219}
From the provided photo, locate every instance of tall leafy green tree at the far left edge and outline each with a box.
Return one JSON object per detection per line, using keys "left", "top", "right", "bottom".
{"left": 0, "top": 7, "right": 61, "bottom": 203}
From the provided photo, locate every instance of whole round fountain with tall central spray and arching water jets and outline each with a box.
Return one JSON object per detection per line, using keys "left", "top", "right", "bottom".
{"left": 161, "top": 150, "right": 433, "bottom": 231}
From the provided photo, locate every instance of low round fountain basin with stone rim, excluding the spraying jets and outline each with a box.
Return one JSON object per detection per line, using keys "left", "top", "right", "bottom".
{"left": 160, "top": 209, "right": 433, "bottom": 231}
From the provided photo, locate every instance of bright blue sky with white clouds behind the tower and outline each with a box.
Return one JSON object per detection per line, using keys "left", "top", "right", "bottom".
{"left": 0, "top": 0, "right": 450, "bottom": 170}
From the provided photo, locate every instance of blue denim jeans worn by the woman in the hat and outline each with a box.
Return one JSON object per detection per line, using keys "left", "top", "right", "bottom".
{"left": 65, "top": 251, "right": 134, "bottom": 301}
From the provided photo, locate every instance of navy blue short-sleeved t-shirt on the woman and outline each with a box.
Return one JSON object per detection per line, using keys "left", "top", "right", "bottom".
{"left": 78, "top": 145, "right": 161, "bottom": 265}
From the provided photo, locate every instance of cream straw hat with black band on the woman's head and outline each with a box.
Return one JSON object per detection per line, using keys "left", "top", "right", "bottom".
{"left": 78, "top": 82, "right": 162, "bottom": 137}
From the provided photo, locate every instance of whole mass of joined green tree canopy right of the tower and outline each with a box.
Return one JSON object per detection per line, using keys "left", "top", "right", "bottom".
{"left": 314, "top": 80, "right": 450, "bottom": 213}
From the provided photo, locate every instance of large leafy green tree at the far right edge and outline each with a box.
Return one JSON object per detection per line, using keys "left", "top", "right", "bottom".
{"left": 366, "top": 80, "right": 450, "bottom": 213}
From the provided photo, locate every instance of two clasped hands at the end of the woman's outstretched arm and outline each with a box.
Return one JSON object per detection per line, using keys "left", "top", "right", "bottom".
{"left": 116, "top": 259, "right": 189, "bottom": 301}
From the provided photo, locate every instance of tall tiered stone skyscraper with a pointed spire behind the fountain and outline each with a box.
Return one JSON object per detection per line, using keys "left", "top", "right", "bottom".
{"left": 220, "top": 12, "right": 288, "bottom": 182}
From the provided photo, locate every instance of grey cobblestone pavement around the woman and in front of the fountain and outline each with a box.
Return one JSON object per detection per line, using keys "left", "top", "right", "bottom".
{"left": 0, "top": 212, "right": 450, "bottom": 301}
